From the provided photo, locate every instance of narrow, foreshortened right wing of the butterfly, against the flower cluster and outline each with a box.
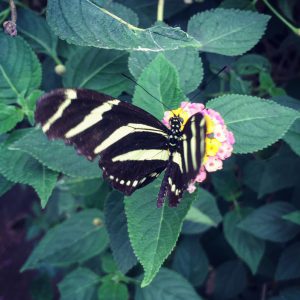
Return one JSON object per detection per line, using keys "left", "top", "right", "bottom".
{"left": 157, "top": 113, "right": 206, "bottom": 207}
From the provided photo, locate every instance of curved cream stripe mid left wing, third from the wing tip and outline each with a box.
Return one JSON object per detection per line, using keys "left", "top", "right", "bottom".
{"left": 94, "top": 123, "right": 167, "bottom": 154}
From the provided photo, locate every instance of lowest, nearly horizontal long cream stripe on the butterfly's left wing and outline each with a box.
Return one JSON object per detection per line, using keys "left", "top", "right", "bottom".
{"left": 112, "top": 149, "right": 169, "bottom": 162}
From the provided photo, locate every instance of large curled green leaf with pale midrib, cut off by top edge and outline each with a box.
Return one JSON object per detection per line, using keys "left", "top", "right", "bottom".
{"left": 47, "top": 0, "right": 200, "bottom": 51}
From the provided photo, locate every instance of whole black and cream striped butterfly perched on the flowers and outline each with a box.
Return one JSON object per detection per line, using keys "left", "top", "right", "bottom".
{"left": 35, "top": 89, "right": 206, "bottom": 207}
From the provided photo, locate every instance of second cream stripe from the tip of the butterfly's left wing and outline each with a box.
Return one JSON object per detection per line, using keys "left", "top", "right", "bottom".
{"left": 65, "top": 99, "right": 120, "bottom": 139}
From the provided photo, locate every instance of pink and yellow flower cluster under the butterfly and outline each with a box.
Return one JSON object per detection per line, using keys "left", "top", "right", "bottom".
{"left": 163, "top": 102, "right": 235, "bottom": 193}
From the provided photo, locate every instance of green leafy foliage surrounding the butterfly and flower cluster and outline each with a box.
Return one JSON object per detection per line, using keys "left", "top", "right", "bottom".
{"left": 0, "top": 0, "right": 300, "bottom": 300}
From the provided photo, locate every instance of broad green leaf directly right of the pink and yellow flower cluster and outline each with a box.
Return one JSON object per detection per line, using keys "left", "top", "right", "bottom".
{"left": 207, "top": 95, "right": 300, "bottom": 153}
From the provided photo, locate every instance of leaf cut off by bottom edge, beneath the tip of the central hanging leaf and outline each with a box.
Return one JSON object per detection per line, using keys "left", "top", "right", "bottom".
{"left": 134, "top": 268, "right": 202, "bottom": 300}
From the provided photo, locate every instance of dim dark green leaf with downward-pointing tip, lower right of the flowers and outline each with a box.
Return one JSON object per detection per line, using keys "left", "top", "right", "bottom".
{"left": 223, "top": 211, "right": 265, "bottom": 274}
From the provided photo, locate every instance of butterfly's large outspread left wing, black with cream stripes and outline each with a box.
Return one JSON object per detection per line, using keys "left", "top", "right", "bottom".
{"left": 35, "top": 89, "right": 169, "bottom": 195}
